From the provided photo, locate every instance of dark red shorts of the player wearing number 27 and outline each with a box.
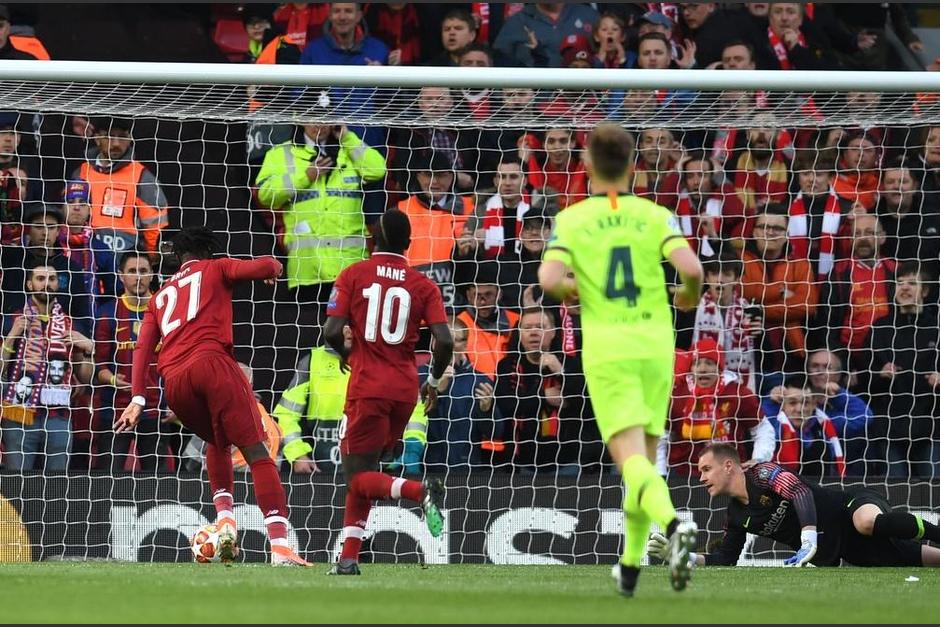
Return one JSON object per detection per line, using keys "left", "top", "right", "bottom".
{"left": 164, "top": 353, "right": 267, "bottom": 448}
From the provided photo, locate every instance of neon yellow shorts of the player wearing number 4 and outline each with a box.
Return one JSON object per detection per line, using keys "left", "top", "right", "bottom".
{"left": 584, "top": 355, "right": 674, "bottom": 444}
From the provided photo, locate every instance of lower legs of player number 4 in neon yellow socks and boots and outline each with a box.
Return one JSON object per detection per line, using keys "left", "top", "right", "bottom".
{"left": 607, "top": 426, "right": 698, "bottom": 596}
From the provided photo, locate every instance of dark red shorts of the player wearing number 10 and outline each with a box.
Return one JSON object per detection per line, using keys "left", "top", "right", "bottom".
{"left": 339, "top": 398, "right": 415, "bottom": 455}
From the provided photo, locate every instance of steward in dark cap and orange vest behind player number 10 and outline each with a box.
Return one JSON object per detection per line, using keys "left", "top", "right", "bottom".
{"left": 398, "top": 150, "right": 473, "bottom": 306}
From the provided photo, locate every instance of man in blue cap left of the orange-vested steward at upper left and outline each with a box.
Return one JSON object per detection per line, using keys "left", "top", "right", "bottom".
{"left": 59, "top": 181, "right": 117, "bottom": 302}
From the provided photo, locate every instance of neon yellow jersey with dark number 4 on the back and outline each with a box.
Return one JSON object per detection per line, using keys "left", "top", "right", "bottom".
{"left": 545, "top": 196, "right": 688, "bottom": 365}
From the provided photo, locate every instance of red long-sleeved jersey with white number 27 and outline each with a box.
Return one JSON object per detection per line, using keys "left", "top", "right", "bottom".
{"left": 132, "top": 257, "right": 281, "bottom": 396}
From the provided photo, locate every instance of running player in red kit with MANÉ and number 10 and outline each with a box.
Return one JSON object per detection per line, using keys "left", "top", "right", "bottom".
{"left": 324, "top": 210, "right": 454, "bottom": 575}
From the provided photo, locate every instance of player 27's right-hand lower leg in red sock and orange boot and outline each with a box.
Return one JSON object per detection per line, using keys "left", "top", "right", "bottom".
{"left": 239, "top": 442, "right": 310, "bottom": 566}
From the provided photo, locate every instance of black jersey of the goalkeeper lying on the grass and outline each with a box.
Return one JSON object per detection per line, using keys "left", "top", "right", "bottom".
{"left": 705, "top": 462, "right": 847, "bottom": 566}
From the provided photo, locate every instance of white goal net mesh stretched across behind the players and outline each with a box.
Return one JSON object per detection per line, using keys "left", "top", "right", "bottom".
{"left": 0, "top": 76, "right": 940, "bottom": 564}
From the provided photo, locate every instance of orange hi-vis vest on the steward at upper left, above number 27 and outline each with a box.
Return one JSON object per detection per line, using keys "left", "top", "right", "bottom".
{"left": 80, "top": 161, "right": 166, "bottom": 252}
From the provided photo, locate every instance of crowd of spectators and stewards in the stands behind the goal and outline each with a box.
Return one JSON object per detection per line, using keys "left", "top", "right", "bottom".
{"left": 0, "top": 3, "right": 940, "bottom": 478}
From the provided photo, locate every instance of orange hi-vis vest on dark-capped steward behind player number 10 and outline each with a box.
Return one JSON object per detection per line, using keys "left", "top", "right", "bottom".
{"left": 398, "top": 196, "right": 473, "bottom": 268}
